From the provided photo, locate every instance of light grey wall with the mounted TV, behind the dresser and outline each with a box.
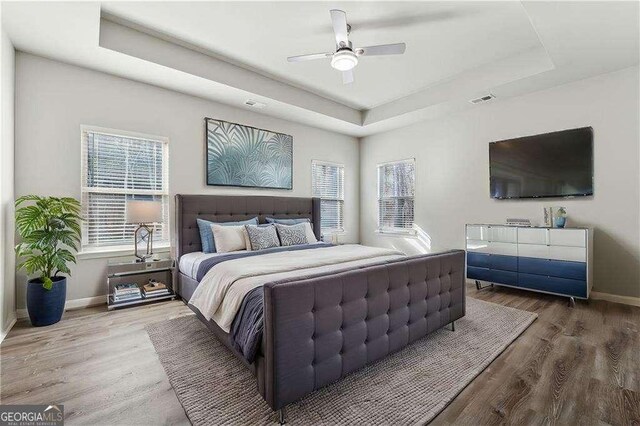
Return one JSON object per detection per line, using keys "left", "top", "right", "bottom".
{"left": 360, "top": 67, "right": 640, "bottom": 297}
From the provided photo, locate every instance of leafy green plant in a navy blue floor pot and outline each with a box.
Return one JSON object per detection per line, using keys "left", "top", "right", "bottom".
{"left": 15, "top": 195, "right": 81, "bottom": 327}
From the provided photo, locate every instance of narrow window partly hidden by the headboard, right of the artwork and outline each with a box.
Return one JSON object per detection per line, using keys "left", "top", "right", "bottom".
{"left": 311, "top": 160, "right": 344, "bottom": 233}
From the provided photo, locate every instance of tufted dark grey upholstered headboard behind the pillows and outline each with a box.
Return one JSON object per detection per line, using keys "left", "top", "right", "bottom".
{"left": 175, "top": 194, "right": 320, "bottom": 259}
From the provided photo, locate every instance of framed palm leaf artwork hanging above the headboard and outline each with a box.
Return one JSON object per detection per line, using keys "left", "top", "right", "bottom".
{"left": 205, "top": 118, "right": 293, "bottom": 189}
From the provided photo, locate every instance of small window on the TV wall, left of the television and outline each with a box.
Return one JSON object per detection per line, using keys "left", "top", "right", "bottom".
{"left": 378, "top": 159, "right": 416, "bottom": 233}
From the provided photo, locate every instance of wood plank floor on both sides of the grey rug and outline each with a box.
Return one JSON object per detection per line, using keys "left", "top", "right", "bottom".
{"left": 0, "top": 284, "right": 640, "bottom": 425}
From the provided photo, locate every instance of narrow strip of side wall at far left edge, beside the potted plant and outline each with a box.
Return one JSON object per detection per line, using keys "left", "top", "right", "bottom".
{"left": 0, "top": 31, "right": 16, "bottom": 336}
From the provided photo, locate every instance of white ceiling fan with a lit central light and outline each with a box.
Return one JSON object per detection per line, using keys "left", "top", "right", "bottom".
{"left": 287, "top": 9, "right": 407, "bottom": 84}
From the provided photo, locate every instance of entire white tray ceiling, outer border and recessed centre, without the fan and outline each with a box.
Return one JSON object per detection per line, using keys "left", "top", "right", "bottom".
{"left": 1, "top": 1, "right": 640, "bottom": 136}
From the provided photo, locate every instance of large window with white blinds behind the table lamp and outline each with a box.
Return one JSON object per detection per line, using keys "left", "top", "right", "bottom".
{"left": 82, "top": 127, "right": 169, "bottom": 251}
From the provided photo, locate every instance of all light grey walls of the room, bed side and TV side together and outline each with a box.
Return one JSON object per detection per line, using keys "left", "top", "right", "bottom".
{"left": 10, "top": 52, "right": 640, "bottom": 307}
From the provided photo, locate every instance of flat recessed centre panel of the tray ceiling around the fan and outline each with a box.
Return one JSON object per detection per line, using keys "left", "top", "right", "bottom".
{"left": 103, "top": 2, "right": 540, "bottom": 109}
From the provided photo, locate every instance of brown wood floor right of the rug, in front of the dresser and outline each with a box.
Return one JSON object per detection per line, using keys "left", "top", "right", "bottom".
{"left": 432, "top": 285, "right": 640, "bottom": 425}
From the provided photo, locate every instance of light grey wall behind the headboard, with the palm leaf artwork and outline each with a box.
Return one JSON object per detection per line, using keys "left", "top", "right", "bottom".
{"left": 15, "top": 52, "right": 360, "bottom": 307}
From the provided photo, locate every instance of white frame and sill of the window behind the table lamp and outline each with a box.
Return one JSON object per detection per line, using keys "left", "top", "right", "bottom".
{"left": 77, "top": 124, "right": 171, "bottom": 255}
